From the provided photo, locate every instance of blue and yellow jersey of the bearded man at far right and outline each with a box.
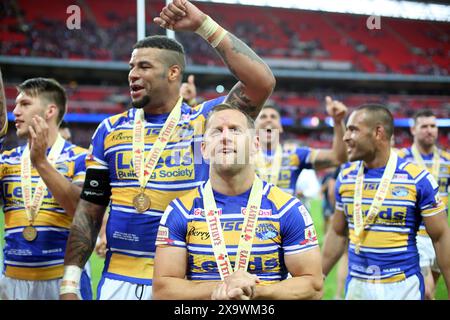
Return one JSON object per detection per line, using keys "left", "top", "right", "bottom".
{"left": 397, "top": 147, "right": 450, "bottom": 236}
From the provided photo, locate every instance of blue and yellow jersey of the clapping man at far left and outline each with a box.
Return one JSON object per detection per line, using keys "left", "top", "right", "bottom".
{"left": 0, "top": 142, "right": 87, "bottom": 280}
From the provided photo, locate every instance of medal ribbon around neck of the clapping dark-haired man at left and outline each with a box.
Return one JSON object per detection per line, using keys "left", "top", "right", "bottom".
{"left": 20, "top": 134, "right": 65, "bottom": 225}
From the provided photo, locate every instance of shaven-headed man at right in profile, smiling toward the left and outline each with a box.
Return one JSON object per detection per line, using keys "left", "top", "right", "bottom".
{"left": 323, "top": 104, "right": 450, "bottom": 300}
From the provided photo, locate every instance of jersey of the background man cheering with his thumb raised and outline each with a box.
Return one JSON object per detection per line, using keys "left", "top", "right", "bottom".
{"left": 256, "top": 144, "right": 318, "bottom": 195}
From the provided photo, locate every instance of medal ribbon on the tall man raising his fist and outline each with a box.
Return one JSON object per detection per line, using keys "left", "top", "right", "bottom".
{"left": 133, "top": 97, "right": 183, "bottom": 190}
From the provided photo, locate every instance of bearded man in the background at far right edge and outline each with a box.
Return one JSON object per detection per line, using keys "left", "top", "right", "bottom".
{"left": 398, "top": 110, "right": 450, "bottom": 299}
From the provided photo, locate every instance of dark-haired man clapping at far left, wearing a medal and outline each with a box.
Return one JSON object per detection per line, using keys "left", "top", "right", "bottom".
{"left": 0, "top": 78, "right": 91, "bottom": 300}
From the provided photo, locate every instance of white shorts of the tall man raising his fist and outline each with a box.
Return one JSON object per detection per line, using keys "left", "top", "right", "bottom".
{"left": 97, "top": 276, "right": 152, "bottom": 300}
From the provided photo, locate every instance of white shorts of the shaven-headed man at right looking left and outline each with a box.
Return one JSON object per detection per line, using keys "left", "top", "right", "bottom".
{"left": 345, "top": 275, "right": 424, "bottom": 300}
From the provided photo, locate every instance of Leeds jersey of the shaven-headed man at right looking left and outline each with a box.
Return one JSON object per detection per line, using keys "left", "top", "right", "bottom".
{"left": 336, "top": 158, "right": 445, "bottom": 282}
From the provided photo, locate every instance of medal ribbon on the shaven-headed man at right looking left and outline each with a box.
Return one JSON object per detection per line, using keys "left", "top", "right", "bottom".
{"left": 353, "top": 151, "right": 398, "bottom": 245}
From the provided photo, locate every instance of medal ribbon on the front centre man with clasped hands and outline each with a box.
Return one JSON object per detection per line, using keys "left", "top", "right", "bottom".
{"left": 203, "top": 176, "right": 263, "bottom": 280}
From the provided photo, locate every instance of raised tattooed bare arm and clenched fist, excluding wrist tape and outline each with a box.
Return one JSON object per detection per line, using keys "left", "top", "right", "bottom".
{"left": 153, "top": 0, "right": 275, "bottom": 118}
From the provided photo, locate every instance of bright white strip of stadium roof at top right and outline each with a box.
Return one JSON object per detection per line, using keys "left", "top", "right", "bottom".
{"left": 196, "top": 0, "right": 450, "bottom": 22}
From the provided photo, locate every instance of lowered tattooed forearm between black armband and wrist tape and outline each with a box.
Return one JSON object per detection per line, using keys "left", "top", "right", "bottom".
{"left": 64, "top": 200, "right": 103, "bottom": 267}
